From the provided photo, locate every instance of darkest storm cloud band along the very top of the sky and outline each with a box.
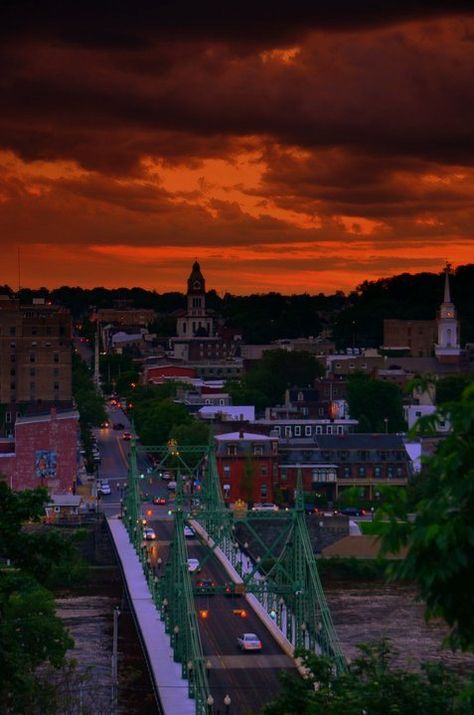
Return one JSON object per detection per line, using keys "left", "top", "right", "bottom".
{"left": 0, "top": 0, "right": 472, "bottom": 49}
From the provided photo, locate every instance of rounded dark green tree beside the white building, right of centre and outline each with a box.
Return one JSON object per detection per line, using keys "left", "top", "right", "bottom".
{"left": 347, "top": 374, "right": 406, "bottom": 432}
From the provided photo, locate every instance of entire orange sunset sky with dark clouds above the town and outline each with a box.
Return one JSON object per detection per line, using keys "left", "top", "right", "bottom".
{"left": 0, "top": 0, "right": 474, "bottom": 294}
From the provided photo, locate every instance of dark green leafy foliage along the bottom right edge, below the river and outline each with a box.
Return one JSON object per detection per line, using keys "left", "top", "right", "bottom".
{"left": 261, "top": 640, "right": 474, "bottom": 715}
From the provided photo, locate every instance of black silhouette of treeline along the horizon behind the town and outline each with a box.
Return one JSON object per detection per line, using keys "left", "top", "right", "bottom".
{"left": 3, "top": 264, "right": 474, "bottom": 347}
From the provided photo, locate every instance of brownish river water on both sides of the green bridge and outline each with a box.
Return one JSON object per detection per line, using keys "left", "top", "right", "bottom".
{"left": 56, "top": 580, "right": 474, "bottom": 715}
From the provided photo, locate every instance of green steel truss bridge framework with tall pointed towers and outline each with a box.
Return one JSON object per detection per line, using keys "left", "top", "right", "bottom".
{"left": 123, "top": 439, "right": 346, "bottom": 715}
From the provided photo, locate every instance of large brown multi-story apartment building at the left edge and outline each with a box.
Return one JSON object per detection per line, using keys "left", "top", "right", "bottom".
{"left": 0, "top": 295, "right": 72, "bottom": 434}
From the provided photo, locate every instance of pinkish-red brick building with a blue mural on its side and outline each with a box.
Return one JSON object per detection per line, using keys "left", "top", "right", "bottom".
{"left": 0, "top": 408, "right": 79, "bottom": 494}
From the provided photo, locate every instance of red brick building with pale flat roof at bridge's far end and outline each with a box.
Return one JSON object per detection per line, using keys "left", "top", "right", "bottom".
{"left": 214, "top": 430, "right": 278, "bottom": 503}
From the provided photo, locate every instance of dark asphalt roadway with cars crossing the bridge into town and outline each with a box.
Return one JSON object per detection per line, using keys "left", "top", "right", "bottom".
{"left": 93, "top": 407, "right": 296, "bottom": 715}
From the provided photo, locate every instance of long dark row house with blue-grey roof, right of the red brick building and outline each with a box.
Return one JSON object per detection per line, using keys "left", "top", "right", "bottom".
{"left": 274, "top": 434, "right": 412, "bottom": 501}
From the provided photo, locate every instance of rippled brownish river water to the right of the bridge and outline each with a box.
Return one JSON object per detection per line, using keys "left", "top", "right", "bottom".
{"left": 323, "top": 580, "right": 474, "bottom": 673}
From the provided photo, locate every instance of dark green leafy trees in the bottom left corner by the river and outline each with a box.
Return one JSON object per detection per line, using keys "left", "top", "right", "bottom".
{"left": 0, "top": 481, "right": 81, "bottom": 715}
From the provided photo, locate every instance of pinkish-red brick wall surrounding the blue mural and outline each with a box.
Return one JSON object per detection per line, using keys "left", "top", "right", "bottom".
{"left": 0, "top": 415, "right": 78, "bottom": 494}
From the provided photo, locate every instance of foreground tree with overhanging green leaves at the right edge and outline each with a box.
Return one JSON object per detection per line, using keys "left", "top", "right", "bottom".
{"left": 377, "top": 385, "right": 474, "bottom": 650}
